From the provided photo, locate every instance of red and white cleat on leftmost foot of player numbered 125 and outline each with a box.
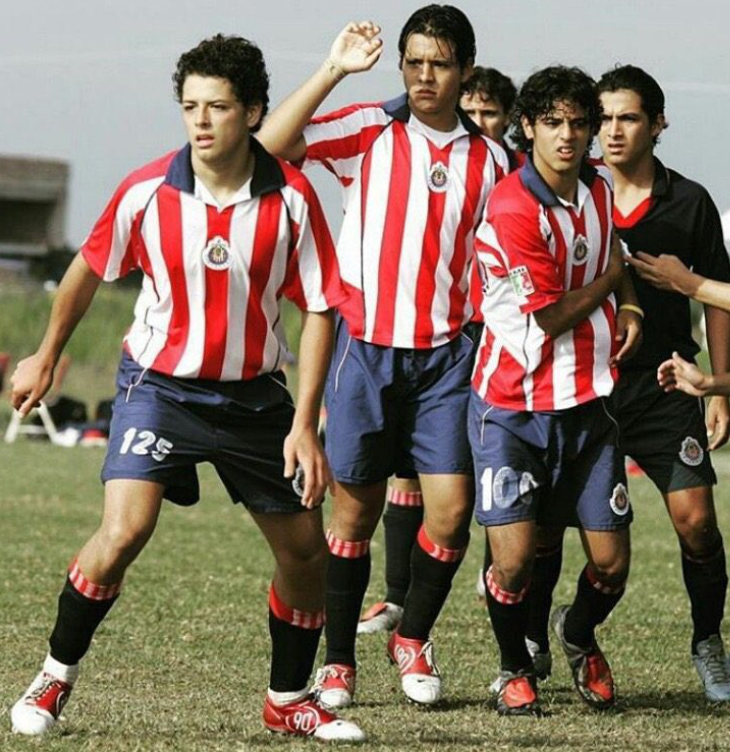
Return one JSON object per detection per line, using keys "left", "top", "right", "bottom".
{"left": 10, "top": 655, "right": 78, "bottom": 736}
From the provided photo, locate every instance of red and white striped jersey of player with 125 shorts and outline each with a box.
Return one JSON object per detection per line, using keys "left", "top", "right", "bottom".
{"left": 81, "top": 139, "right": 344, "bottom": 381}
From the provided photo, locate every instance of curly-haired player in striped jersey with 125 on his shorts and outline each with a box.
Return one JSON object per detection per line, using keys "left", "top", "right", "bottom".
{"left": 11, "top": 35, "right": 364, "bottom": 741}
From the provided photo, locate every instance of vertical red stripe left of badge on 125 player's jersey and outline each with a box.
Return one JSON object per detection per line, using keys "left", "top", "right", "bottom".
{"left": 152, "top": 185, "right": 189, "bottom": 374}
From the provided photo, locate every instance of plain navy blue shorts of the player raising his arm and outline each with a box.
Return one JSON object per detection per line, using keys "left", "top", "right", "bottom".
{"left": 325, "top": 319, "right": 474, "bottom": 485}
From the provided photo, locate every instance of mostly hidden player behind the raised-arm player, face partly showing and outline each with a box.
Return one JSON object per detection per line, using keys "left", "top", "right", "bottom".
{"left": 357, "top": 65, "right": 524, "bottom": 634}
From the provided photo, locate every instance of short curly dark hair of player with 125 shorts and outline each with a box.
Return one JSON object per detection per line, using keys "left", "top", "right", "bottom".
{"left": 172, "top": 34, "right": 269, "bottom": 131}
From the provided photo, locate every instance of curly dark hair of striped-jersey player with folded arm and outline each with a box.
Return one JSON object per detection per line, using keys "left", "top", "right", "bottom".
{"left": 510, "top": 65, "right": 602, "bottom": 157}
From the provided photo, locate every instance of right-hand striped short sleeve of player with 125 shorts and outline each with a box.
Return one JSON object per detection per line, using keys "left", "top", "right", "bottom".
{"left": 281, "top": 174, "right": 347, "bottom": 312}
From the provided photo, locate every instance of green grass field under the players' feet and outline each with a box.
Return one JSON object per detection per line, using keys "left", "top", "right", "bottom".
{"left": 0, "top": 439, "right": 730, "bottom": 752}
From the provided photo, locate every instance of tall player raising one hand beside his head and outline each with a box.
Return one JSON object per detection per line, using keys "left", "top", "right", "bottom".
{"left": 262, "top": 5, "right": 507, "bottom": 707}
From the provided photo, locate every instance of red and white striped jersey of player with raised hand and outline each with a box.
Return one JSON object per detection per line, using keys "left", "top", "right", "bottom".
{"left": 304, "top": 94, "right": 508, "bottom": 348}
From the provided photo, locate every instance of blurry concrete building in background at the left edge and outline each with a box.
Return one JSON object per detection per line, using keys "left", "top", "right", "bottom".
{"left": 0, "top": 156, "right": 69, "bottom": 258}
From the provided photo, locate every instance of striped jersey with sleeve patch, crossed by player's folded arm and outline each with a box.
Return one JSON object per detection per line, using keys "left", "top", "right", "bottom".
{"left": 472, "top": 155, "right": 616, "bottom": 411}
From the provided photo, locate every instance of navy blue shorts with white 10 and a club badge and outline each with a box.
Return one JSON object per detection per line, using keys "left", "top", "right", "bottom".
{"left": 469, "top": 391, "right": 633, "bottom": 530}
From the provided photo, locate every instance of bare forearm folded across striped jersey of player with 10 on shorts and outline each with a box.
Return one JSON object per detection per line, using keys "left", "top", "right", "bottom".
{"left": 534, "top": 236, "right": 624, "bottom": 339}
